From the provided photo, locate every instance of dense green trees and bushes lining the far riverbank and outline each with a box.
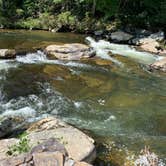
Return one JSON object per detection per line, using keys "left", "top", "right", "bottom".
{"left": 0, "top": 0, "right": 166, "bottom": 33}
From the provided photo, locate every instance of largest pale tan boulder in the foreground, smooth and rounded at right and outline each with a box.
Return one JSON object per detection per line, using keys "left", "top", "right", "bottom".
{"left": 27, "top": 118, "right": 96, "bottom": 162}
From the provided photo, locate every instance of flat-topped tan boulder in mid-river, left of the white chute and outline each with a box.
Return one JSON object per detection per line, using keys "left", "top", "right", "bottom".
{"left": 44, "top": 43, "right": 94, "bottom": 60}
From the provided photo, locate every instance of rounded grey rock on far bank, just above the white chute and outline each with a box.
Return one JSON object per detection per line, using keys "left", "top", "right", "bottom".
{"left": 111, "top": 31, "right": 133, "bottom": 43}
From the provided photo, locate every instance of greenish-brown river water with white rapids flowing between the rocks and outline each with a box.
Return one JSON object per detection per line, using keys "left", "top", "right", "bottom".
{"left": 0, "top": 31, "right": 166, "bottom": 166}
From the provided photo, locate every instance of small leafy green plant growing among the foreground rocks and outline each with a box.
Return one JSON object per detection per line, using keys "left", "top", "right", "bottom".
{"left": 7, "top": 133, "right": 31, "bottom": 156}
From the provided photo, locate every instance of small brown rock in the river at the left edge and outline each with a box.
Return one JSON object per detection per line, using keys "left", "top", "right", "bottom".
{"left": 0, "top": 49, "right": 16, "bottom": 59}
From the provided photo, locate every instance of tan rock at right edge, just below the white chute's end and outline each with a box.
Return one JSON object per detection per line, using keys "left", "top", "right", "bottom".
{"left": 150, "top": 58, "right": 166, "bottom": 72}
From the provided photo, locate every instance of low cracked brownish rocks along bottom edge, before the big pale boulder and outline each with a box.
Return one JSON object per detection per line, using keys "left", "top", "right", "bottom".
{"left": 0, "top": 139, "right": 90, "bottom": 166}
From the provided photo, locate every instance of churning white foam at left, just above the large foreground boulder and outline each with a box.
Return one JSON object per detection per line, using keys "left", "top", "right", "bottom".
{"left": 0, "top": 83, "right": 74, "bottom": 121}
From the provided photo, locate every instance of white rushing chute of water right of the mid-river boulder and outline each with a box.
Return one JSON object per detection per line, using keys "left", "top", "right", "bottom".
{"left": 86, "top": 37, "right": 159, "bottom": 65}
